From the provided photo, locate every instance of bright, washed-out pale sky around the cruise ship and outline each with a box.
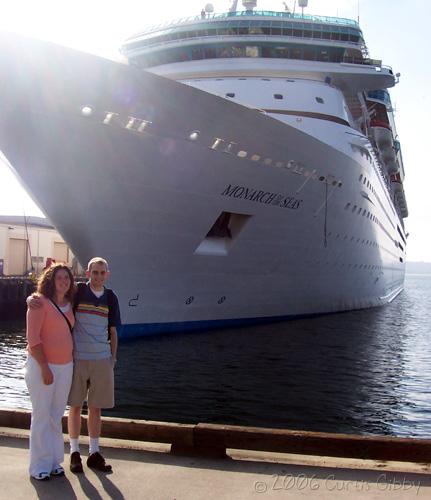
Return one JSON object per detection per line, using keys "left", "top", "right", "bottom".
{"left": 0, "top": 0, "right": 431, "bottom": 262}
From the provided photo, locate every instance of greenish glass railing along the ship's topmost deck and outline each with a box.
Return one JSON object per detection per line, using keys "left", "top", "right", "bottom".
{"left": 127, "top": 10, "right": 359, "bottom": 41}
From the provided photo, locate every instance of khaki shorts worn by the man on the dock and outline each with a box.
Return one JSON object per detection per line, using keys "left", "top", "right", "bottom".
{"left": 68, "top": 358, "right": 114, "bottom": 408}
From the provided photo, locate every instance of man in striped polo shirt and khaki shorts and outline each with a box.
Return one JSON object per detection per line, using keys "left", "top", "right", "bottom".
{"left": 68, "top": 257, "right": 121, "bottom": 473}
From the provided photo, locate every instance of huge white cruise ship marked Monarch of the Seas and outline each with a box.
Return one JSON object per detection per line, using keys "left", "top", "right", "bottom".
{"left": 0, "top": 0, "right": 408, "bottom": 337}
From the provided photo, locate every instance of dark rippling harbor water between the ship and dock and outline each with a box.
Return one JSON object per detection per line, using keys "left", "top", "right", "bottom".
{"left": 0, "top": 275, "right": 431, "bottom": 437}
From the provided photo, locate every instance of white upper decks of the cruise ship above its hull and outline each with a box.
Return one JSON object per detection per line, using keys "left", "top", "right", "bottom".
{"left": 122, "top": 1, "right": 408, "bottom": 218}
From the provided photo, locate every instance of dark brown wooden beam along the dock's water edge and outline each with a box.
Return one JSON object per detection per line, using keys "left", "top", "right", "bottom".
{"left": 0, "top": 409, "right": 431, "bottom": 464}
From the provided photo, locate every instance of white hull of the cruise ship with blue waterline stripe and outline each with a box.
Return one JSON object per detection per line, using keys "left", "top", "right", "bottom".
{"left": 0, "top": 32, "right": 405, "bottom": 336}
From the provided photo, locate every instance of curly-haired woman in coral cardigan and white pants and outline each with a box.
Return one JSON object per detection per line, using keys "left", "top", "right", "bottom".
{"left": 25, "top": 264, "right": 75, "bottom": 481}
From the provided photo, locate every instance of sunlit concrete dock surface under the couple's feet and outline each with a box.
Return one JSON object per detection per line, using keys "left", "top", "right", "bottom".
{"left": 0, "top": 427, "right": 431, "bottom": 500}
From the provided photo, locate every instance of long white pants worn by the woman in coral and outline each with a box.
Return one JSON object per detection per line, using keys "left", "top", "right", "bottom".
{"left": 25, "top": 355, "right": 73, "bottom": 476}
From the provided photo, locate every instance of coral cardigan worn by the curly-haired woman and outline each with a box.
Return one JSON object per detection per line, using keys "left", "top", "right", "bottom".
{"left": 27, "top": 296, "right": 75, "bottom": 365}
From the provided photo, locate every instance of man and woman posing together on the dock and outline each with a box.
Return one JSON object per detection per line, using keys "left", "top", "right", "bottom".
{"left": 25, "top": 257, "right": 121, "bottom": 480}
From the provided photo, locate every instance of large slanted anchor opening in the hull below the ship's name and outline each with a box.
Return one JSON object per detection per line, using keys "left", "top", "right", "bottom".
{"left": 194, "top": 212, "right": 251, "bottom": 257}
